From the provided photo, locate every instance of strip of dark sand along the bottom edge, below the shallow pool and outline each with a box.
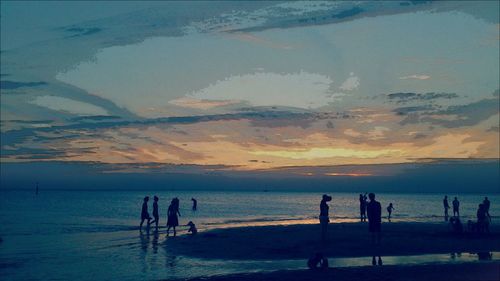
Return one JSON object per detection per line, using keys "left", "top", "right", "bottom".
{"left": 185, "top": 262, "right": 500, "bottom": 281}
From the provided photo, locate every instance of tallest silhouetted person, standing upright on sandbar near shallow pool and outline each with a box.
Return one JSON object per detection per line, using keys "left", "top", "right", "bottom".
{"left": 366, "top": 193, "right": 382, "bottom": 265}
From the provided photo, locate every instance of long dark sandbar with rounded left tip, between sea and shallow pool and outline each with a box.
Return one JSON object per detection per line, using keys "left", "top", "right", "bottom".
{"left": 165, "top": 223, "right": 500, "bottom": 260}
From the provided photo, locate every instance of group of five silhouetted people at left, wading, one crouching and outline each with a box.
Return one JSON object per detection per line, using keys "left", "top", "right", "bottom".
{"left": 139, "top": 196, "right": 198, "bottom": 236}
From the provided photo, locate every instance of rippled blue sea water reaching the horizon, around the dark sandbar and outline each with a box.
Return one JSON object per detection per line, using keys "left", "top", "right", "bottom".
{"left": 0, "top": 190, "right": 500, "bottom": 280}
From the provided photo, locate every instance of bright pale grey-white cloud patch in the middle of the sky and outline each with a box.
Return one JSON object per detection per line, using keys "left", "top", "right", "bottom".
{"left": 186, "top": 71, "right": 333, "bottom": 108}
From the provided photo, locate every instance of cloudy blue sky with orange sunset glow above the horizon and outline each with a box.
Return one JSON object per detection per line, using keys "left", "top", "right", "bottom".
{"left": 0, "top": 1, "right": 500, "bottom": 190}
